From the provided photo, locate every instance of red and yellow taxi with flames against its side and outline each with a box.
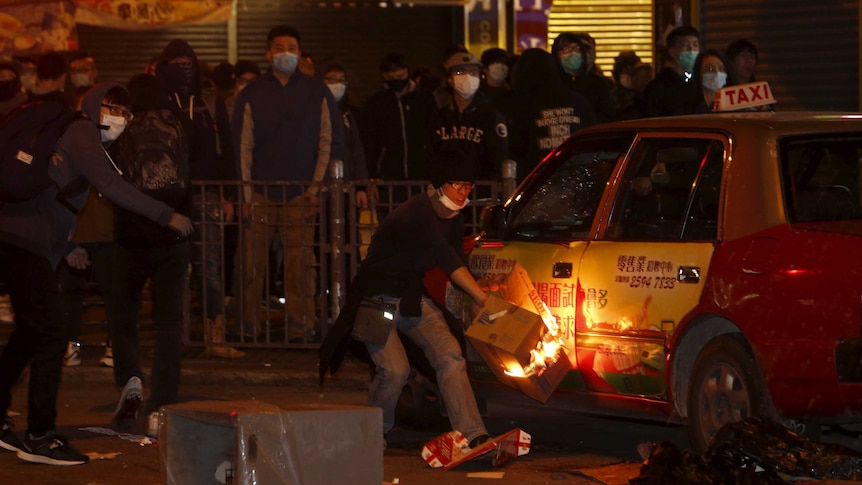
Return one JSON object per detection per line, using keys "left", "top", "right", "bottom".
{"left": 468, "top": 112, "right": 862, "bottom": 451}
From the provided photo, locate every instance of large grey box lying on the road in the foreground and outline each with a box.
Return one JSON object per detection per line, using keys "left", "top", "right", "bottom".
{"left": 159, "top": 401, "right": 383, "bottom": 485}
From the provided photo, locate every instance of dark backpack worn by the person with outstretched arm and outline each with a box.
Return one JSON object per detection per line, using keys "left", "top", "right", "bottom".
{"left": 0, "top": 101, "right": 77, "bottom": 204}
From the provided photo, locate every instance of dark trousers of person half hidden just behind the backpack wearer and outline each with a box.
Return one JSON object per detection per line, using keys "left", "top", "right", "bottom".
{"left": 53, "top": 242, "right": 114, "bottom": 342}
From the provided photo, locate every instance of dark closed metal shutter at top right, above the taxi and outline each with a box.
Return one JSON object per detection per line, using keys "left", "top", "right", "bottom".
{"left": 700, "top": 0, "right": 859, "bottom": 111}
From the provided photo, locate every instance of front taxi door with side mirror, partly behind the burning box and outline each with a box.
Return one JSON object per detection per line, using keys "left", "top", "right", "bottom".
{"left": 468, "top": 132, "right": 635, "bottom": 390}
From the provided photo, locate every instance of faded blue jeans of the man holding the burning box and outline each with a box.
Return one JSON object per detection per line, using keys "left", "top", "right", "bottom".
{"left": 365, "top": 297, "right": 487, "bottom": 440}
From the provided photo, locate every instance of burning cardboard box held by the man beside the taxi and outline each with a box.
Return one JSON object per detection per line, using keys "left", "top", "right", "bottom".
{"left": 466, "top": 296, "right": 572, "bottom": 403}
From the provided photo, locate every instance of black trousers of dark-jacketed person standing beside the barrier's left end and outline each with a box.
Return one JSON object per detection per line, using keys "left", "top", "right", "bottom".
{"left": 110, "top": 241, "right": 191, "bottom": 413}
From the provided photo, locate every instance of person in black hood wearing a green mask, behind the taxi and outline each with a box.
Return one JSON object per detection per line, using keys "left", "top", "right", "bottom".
{"left": 551, "top": 32, "right": 619, "bottom": 122}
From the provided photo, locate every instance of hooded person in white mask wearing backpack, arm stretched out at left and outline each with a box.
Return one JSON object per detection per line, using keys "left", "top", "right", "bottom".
{"left": 0, "top": 80, "right": 193, "bottom": 465}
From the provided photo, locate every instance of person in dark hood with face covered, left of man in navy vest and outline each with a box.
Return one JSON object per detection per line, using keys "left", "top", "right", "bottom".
{"left": 156, "top": 39, "right": 240, "bottom": 357}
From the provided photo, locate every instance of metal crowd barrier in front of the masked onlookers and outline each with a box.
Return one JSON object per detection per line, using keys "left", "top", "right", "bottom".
{"left": 184, "top": 162, "right": 515, "bottom": 348}
